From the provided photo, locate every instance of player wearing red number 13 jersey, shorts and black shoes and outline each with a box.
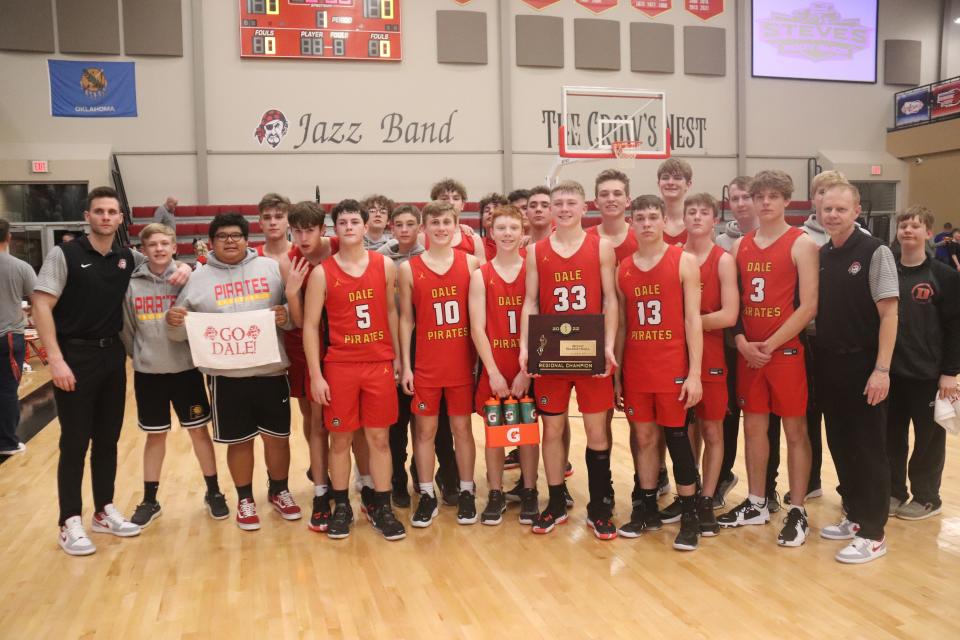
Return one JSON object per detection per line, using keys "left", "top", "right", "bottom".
{"left": 614, "top": 196, "right": 703, "bottom": 551}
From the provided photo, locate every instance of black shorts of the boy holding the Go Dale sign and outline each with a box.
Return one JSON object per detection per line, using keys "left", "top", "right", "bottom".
{"left": 207, "top": 374, "right": 290, "bottom": 444}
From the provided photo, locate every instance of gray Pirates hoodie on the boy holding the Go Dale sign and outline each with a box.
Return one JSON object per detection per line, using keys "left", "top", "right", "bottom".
{"left": 167, "top": 249, "right": 293, "bottom": 378}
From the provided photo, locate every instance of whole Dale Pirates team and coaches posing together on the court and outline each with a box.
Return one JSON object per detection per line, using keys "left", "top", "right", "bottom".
{"left": 33, "top": 158, "right": 960, "bottom": 564}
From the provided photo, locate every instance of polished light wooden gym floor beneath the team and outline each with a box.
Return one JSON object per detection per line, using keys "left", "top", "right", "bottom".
{"left": 0, "top": 363, "right": 960, "bottom": 640}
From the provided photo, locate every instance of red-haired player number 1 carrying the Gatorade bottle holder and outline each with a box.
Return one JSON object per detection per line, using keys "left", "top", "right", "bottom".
{"left": 470, "top": 205, "right": 540, "bottom": 525}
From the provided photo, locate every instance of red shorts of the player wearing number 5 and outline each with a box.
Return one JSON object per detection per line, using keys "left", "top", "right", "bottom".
{"left": 323, "top": 360, "right": 399, "bottom": 433}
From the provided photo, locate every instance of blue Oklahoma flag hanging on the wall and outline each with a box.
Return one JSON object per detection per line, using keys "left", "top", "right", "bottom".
{"left": 47, "top": 60, "right": 137, "bottom": 118}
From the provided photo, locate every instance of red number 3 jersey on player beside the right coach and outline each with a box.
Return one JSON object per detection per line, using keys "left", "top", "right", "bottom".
{"left": 737, "top": 227, "right": 803, "bottom": 356}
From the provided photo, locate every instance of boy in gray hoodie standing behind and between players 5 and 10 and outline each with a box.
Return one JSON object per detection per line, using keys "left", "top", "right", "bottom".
{"left": 377, "top": 204, "right": 423, "bottom": 509}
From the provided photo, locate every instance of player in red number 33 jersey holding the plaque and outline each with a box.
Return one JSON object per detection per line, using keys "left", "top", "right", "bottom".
{"left": 520, "top": 181, "right": 618, "bottom": 540}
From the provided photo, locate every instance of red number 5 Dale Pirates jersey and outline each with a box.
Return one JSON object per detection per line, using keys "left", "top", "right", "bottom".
{"left": 320, "top": 251, "right": 394, "bottom": 362}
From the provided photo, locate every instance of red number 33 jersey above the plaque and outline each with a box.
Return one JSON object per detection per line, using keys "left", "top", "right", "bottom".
{"left": 536, "top": 233, "right": 603, "bottom": 315}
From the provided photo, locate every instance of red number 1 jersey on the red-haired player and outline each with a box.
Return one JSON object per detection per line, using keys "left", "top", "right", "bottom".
{"left": 480, "top": 262, "right": 527, "bottom": 381}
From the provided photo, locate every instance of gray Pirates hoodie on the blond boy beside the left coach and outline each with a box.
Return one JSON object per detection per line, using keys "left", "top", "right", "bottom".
{"left": 120, "top": 262, "right": 193, "bottom": 373}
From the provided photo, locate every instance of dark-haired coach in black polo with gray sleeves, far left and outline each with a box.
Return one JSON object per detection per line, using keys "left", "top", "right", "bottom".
{"left": 33, "top": 187, "right": 190, "bottom": 555}
